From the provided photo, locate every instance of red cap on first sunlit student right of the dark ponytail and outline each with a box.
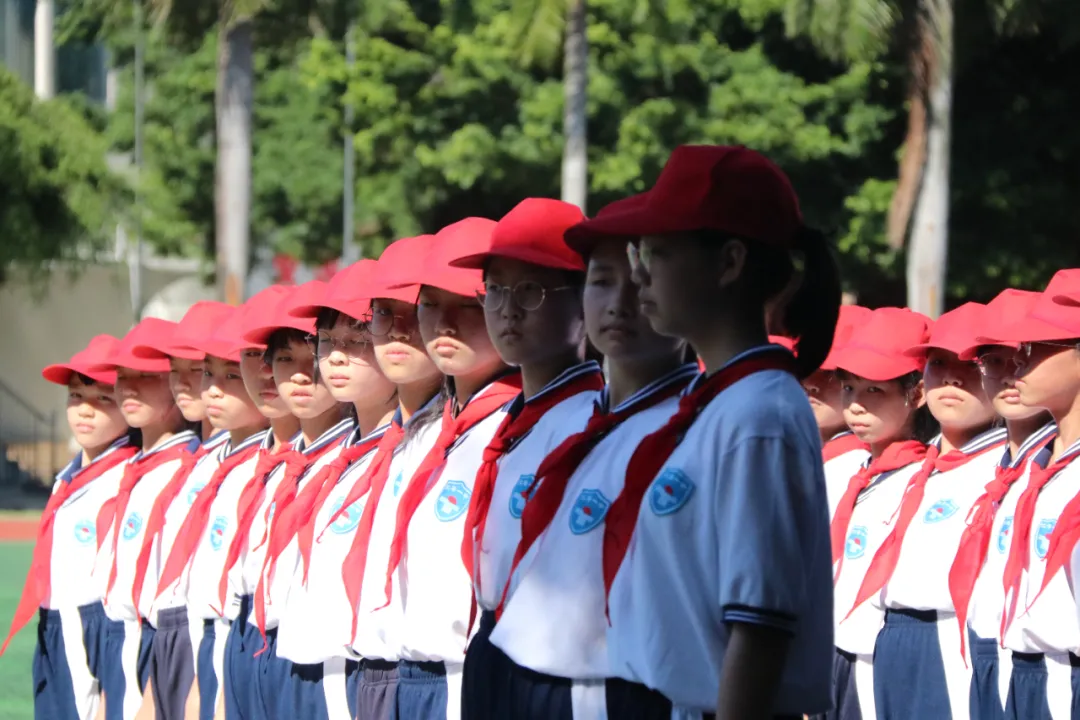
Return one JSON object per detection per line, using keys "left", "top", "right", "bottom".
{"left": 833, "top": 308, "right": 931, "bottom": 382}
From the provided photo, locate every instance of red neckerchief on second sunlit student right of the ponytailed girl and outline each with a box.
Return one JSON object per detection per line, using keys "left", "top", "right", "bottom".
{"left": 845, "top": 438, "right": 1005, "bottom": 620}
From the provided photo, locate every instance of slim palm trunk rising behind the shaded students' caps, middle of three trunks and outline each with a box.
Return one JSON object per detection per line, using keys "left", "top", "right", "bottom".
{"left": 563, "top": 0, "right": 589, "bottom": 213}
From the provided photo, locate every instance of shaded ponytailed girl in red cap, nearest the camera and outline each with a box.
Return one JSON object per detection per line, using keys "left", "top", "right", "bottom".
{"left": 557, "top": 146, "right": 840, "bottom": 719}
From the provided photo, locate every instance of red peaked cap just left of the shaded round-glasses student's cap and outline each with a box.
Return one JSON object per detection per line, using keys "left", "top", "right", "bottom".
{"left": 386, "top": 217, "right": 498, "bottom": 298}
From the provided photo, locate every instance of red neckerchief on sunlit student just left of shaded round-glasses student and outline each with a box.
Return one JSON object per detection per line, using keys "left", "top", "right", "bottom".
{"left": 378, "top": 372, "right": 522, "bottom": 608}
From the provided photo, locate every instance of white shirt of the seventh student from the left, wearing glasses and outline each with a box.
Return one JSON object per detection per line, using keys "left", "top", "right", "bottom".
{"left": 276, "top": 425, "right": 390, "bottom": 665}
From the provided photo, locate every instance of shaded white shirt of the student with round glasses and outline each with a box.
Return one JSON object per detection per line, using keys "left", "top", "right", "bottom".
{"left": 473, "top": 361, "right": 599, "bottom": 610}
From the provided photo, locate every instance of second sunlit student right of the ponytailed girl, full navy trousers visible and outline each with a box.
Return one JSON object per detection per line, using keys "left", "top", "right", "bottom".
{"left": 855, "top": 302, "right": 1007, "bottom": 719}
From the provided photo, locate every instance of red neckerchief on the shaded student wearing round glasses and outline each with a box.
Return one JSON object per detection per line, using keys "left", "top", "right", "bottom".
{"left": 461, "top": 371, "right": 604, "bottom": 630}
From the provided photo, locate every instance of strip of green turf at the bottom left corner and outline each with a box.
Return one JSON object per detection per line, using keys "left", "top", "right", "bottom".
{"left": 0, "top": 543, "right": 38, "bottom": 720}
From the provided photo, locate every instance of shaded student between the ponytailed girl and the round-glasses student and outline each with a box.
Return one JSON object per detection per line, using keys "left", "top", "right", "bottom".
{"left": 483, "top": 203, "right": 698, "bottom": 720}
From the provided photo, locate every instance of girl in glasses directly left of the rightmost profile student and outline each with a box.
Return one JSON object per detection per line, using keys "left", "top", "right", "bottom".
{"left": 948, "top": 289, "right": 1055, "bottom": 720}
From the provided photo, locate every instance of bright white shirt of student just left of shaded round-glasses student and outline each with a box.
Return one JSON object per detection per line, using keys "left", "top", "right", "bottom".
{"left": 392, "top": 385, "right": 527, "bottom": 665}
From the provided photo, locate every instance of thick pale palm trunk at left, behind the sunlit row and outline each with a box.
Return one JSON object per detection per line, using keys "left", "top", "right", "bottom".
{"left": 214, "top": 18, "right": 255, "bottom": 305}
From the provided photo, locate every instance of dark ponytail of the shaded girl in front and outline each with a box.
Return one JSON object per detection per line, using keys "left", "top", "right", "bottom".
{"left": 783, "top": 227, "right": 841, "bottom": 378}
